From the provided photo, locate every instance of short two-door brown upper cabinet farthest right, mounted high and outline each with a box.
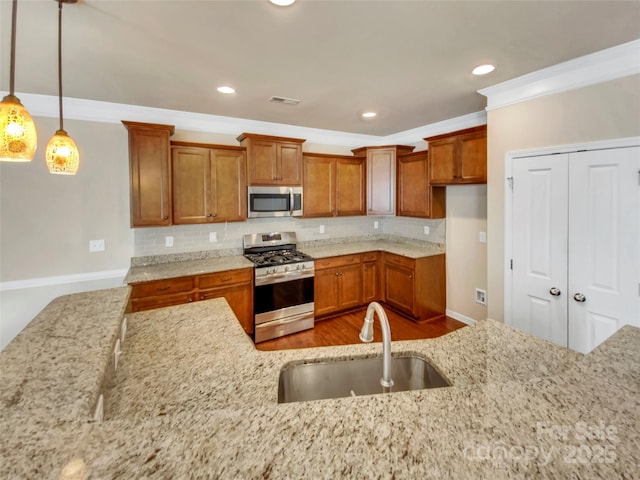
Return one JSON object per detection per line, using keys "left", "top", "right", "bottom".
{"left": 425, "top": 125, "right": 487, "bottom": 185}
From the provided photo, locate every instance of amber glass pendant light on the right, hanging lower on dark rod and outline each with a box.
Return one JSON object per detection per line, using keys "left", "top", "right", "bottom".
{"left": 45, "top": 0, "right": 80, "bottom": 175}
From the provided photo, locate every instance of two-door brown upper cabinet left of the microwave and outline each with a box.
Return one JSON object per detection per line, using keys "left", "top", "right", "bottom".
{"left": 171, "top": 142, "right": 247, "bottom": 225}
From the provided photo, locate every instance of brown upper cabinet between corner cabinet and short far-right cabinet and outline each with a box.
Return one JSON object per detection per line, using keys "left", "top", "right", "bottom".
{"left": 396, "top": 150, "right": 446, "bottom": 218}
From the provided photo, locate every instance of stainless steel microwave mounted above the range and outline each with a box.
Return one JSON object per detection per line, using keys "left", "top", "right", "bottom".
{"left": 247, "top": 187, "right": 302, "bottom": 218}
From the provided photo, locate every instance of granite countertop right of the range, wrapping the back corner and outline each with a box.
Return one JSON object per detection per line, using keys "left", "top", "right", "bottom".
{"left": 298, "top": 239, "right": 445, "bottom": 259}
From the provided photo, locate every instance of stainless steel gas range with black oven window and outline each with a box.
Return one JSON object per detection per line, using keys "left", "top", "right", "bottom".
{"left": 243, "top": 232, "right": 314, "bottom": 343}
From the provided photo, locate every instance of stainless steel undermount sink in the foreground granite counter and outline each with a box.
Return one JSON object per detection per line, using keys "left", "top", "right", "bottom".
{"left": 278, "top": 355, "right": 451, "bottom": 403}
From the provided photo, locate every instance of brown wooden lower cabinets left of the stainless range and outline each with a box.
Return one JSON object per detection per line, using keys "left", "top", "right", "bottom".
{"left": 131, "top": 268, "right": 253, "bottom": 335}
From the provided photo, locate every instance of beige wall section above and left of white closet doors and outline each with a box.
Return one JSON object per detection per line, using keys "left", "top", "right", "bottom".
{"left": 487, "top": 75, "right": 640, "bottom": 321}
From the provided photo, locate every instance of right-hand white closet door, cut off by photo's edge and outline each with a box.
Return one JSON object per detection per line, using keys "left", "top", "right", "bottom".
{"left": 567, "top": 147, "right": 640, "bottom": 353}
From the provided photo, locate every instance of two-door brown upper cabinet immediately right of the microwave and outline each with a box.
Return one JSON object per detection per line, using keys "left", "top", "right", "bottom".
{"left": 302, "top": 153, "right": 366, "bottom": 217}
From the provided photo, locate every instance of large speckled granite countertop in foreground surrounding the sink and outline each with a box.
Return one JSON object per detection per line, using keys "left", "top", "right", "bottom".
{"left": 0, "top": 294, "right": 640, "bottom": 479}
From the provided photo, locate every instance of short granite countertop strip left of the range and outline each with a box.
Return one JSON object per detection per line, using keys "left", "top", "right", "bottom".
{"left": 124, "top": 255, "right": 253, "bottom": 284}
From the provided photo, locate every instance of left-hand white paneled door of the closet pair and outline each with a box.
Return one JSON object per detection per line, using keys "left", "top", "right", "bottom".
{"left": 511, "top": 154, "right": 568, "bottom": 346}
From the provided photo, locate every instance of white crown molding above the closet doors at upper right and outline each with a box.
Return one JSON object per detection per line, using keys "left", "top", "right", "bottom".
{"left": 478, "top": 40, "right": 640, "bottom": 110}
